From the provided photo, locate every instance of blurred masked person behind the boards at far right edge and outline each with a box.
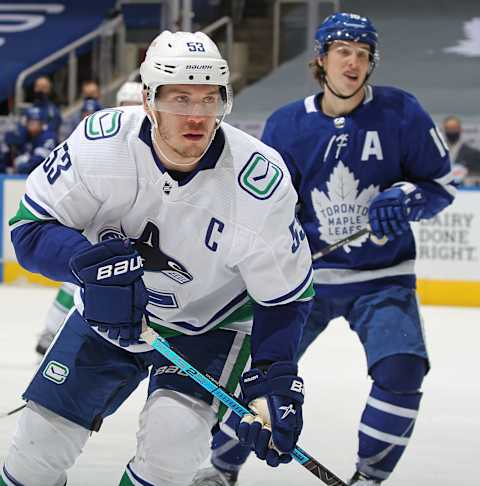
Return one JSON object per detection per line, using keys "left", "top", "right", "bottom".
{"left": 443, "top": 115, "right": 480, "bottom": 185}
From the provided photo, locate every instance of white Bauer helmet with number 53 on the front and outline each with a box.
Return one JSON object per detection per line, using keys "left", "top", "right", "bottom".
{"left": 140, "top": 30, "right": 233, "bottom": 118}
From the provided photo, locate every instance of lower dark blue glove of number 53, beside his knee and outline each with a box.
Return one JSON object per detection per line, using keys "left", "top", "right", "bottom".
{"left": 237, "top": 361, "right": 304, "bottom": 467}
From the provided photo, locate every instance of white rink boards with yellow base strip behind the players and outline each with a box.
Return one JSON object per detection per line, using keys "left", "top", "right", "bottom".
{"left": 0, "top": 175, "right": 480, "bottom": 307}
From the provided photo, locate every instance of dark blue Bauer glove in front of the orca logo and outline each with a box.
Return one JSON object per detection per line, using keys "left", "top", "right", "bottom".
{"left": 70, "top": 239, "right": 148, "bottom": 346}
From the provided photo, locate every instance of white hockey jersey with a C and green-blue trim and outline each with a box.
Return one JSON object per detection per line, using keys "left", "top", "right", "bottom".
{"left": 17, "top": 106, "right": 312, "bottom": 351}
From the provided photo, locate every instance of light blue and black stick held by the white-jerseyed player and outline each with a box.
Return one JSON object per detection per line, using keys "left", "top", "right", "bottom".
{"left": 141, "top": 328, "right": 347, "bottom": 486}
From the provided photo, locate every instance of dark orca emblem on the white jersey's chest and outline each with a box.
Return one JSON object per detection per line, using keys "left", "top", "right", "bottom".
{"left": 133, "top": 222, "right": 193, "bottom": 284}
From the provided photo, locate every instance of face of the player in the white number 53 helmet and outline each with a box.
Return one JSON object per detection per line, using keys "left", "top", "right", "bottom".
{"left": 153, "top": 84, "right": 222, "bottom": 159}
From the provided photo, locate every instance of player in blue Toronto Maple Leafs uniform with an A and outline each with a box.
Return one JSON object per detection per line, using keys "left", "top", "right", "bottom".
{"left": 194, "top": 13, "right": 455, "bottom": 486}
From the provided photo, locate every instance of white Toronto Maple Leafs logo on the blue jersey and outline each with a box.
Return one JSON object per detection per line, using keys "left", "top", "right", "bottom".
{"left": 312, "top": 160, "right": 379, "bottom": 253}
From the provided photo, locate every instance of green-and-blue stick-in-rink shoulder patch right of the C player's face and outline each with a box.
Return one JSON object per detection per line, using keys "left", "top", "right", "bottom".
{"left": 238, "top": 152, "right": 283, "bottom": 199}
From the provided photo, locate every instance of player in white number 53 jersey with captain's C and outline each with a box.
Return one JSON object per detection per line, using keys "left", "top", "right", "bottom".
{"left": 0, "top": 31, "right": 313, "bottom": 486}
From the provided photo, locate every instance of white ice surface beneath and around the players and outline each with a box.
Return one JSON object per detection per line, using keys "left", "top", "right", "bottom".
{"left": 0, "top": 285, "right": 480, "bottom": 486}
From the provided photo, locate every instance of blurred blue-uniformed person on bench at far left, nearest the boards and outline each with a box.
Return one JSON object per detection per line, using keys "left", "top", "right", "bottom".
{"left": 2, "top": 106, "right": 57, "bottom": 174}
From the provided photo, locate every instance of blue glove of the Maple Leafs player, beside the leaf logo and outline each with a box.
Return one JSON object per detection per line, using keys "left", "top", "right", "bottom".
{"left": 368, "top": 183, "right": 425, "bottom": 240}
